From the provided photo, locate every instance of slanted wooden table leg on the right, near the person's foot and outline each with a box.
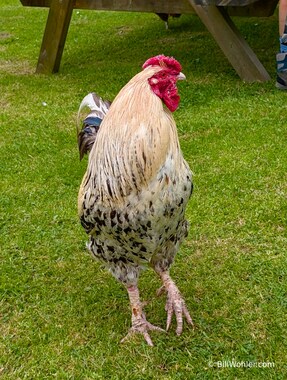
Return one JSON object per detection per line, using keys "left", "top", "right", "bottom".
{"left": 189, "top": 0, "right": 270, "bottom": 82}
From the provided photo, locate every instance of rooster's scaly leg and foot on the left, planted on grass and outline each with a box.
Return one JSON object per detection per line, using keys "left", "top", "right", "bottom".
{"left": 121, "top": 285, "right": 164, "bottom": 346}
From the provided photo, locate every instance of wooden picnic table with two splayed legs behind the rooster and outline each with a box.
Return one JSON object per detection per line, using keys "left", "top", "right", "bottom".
{"left": 20, "top": 0, "right": 278, "bottom": 82}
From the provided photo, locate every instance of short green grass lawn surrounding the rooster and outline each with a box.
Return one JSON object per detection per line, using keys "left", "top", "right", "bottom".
{"left": 0, "top": 0, "right": 287, "bottom": 380}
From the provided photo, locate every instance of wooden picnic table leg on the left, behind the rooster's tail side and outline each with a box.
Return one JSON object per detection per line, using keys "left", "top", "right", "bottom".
{"left": 36, "top": 0, "right": 74, "bottom": 74}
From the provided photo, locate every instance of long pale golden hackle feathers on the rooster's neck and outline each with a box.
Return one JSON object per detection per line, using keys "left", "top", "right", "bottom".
{"left": 83, "top": 67, "right": 181, "bottom": 203}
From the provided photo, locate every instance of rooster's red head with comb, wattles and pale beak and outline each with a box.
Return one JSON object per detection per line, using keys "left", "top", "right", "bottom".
{"left": 143, "top": 55, "right": 185, "bottom": 112}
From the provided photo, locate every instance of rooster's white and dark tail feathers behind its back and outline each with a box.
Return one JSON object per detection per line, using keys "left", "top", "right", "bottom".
{"left": 77, "top": 93, "right": 111, "bottom": 160}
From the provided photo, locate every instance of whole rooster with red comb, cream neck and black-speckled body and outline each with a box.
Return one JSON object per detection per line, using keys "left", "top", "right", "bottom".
{"left": 78, "top": 55, "right": 193, "bottom": 346}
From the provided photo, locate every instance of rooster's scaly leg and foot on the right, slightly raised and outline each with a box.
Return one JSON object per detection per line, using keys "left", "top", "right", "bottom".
{"left": 158, "top": 271, "right": 193, "bottom": 335}
